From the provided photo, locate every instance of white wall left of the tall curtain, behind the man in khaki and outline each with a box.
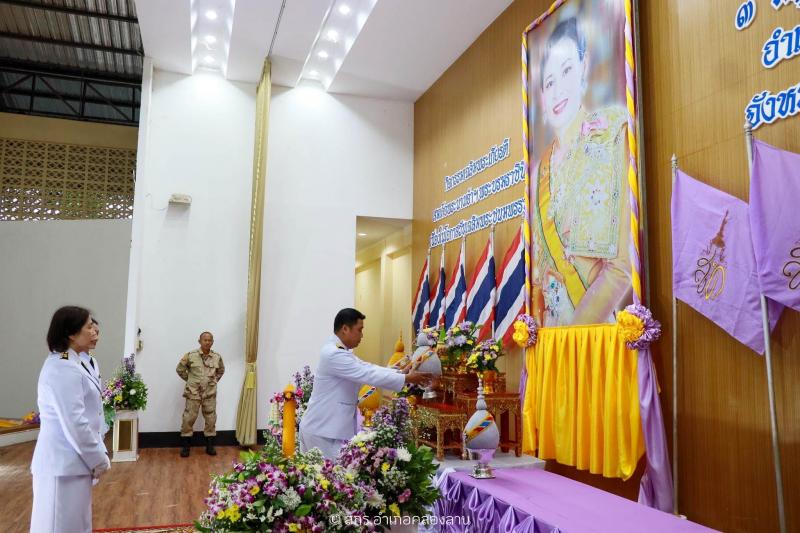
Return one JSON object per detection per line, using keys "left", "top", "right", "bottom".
{"left": 132, "top": 70, "right": 256, "bottom": 432}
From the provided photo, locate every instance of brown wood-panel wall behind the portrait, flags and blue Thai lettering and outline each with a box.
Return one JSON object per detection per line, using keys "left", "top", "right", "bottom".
{"left": 412, "top": 0, "right": 800, "bottom": 532}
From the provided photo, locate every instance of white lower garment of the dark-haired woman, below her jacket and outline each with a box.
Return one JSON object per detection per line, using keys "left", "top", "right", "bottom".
{"left": 31, "top": 475, "right": 92, "bottom": 533}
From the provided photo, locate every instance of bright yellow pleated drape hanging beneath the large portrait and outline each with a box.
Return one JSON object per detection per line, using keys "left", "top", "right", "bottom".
{"left": 522, "top": 324, "right": 644, "bottom": 479}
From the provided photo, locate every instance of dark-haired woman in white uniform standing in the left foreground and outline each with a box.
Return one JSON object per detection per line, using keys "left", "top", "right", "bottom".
{"left": 31, "top": 306, "right": 111, "bottom": 533}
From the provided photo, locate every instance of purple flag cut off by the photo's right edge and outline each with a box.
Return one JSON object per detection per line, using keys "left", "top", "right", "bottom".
{"left": 750, "top": 140, "right": 800, "bottom": 311}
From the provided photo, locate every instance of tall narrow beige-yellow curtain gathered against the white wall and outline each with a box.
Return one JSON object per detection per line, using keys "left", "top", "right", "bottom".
{"left": 236, "top": 59, "right": 272, "bottom": 446}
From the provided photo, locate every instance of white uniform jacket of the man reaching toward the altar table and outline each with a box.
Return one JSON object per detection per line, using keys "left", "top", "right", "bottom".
{"left": 300, "top": 335, "right": 405, "bottom": 440}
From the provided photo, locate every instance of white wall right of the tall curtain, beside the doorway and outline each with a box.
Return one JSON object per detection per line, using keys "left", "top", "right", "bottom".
{"left": 258, "top": 87, "right": 414, "bottom": 416}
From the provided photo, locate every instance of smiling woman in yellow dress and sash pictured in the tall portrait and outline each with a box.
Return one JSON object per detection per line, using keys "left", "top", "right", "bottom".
{"left": 529, "top": 12, "right": 632, "bottom": 326}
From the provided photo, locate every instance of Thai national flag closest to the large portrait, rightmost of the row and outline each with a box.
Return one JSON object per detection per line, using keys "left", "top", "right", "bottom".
{"left": 494, "top": 229, "right": 525, "bottom": 345}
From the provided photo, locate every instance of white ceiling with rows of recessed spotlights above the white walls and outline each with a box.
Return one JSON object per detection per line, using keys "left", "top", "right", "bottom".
{"left": 136, "top": 0, "right": 511, "bottom": 102}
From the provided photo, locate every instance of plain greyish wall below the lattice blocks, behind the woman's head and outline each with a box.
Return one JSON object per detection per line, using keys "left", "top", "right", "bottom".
{"left": 0, "top": 220, "right": 131, "bottom": 417}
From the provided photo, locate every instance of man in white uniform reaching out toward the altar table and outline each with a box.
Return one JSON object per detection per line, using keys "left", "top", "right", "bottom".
{"left": 300, "top": 308, "right": 432, "bottom": 459}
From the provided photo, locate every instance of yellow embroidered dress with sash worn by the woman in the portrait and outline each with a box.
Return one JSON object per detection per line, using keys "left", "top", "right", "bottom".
{"left": 530, "top": 107, "right": 631, "bottom": 326}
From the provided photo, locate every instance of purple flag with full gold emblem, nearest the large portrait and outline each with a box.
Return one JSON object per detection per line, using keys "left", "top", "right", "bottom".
{"left": 672, "top": 170, "right": 783, "bottom": 354}
